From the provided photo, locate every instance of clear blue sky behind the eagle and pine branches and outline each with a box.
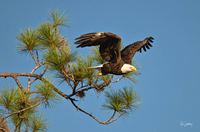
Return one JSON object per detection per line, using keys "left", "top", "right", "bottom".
{"left": 0, "top": 0, "right": 200, "bottom": 132}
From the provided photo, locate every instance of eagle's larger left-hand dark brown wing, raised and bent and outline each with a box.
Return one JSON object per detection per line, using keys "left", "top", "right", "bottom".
{"left": 75, "top": 32, "right": 121, "bottom": 62}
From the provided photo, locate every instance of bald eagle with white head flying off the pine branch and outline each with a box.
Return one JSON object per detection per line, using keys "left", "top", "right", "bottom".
{"left": 75, "top": 32, "right": 154, "bottom": 75}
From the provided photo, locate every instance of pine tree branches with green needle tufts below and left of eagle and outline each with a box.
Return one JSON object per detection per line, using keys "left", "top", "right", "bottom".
{"left": 0, "top": 11, "right": 138, "bottom": 132}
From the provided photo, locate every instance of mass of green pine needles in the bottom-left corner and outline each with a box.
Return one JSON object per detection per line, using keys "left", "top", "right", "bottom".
{"left": 0, "top": 88, "right": 46, "bottom": 131}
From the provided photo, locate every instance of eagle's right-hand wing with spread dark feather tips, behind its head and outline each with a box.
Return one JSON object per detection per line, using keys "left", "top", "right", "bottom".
{"left": 121, "top": 37, "right": 154, "bottom": 64}
